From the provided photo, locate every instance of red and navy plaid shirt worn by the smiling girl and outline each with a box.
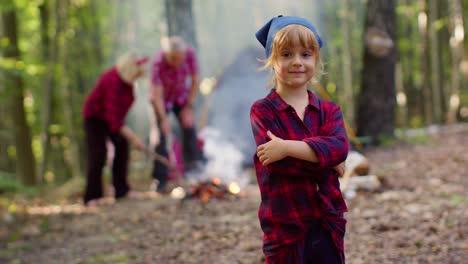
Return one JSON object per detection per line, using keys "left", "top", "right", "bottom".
{"left": 250, "top": 90, "right": 349, "bottom": 256}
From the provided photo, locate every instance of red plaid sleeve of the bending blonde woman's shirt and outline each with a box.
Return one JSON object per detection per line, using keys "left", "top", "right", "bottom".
{"left": 101, "top": 79, "right": 125, "bottom": 133}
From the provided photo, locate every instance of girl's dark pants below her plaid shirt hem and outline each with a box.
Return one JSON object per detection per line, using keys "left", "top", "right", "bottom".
{"left": 265, "top": 222, "right": 344, "bottom": 264}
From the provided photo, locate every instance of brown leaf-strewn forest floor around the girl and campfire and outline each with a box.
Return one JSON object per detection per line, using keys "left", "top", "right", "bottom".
{"left": 0, "top": 127, "right": 468, "bottom": 264}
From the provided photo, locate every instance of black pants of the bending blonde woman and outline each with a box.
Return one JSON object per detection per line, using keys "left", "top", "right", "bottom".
{"left": 83, "top": 118, "right": 130, "bottom": 204}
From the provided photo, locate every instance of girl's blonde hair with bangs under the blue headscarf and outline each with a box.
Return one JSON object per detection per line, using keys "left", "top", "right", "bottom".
{"left": 260, "top": 24, "right": 325, "bottom": 86}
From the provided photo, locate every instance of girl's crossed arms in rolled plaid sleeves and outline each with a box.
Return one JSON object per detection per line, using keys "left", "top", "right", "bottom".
{"left": 251, "top": 102, "right": 349, "bottom": 175}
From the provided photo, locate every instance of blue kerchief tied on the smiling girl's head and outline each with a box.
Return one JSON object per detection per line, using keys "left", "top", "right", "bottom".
{"left": 255, "top": 15, "right": 322, "bottom": 58}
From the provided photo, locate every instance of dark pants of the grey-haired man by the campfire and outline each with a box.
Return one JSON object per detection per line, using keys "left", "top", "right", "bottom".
{"left": 152, "top": 105, "right": 203, "bottom": 191}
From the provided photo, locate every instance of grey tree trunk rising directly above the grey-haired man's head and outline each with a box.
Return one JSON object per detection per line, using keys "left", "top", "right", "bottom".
{"left": 164, "top": 0, "right": 197, "bottom": 48}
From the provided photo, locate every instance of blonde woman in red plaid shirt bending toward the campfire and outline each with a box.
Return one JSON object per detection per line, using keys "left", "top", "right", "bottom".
{"left": 83, "top": 52, "right": 148, "bottom": 206}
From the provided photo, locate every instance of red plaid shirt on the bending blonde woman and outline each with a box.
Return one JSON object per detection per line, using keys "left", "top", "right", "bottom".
{"left": 83, "top": 67, "right": 134, "bottom": 133}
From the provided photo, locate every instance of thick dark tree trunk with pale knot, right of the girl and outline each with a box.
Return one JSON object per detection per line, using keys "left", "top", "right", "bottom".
{"left": 357, "top": 0, "right": 397, "bottom": 143}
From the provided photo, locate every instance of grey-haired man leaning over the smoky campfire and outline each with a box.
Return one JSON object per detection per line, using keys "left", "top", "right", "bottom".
{"left": 149, "top": 36, "right": 203, "bottom": 192}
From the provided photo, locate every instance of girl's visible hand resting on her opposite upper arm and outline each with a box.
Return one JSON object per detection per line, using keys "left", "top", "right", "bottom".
{"left": 257, "top": 131, "right": 287, "bottom": 166}
